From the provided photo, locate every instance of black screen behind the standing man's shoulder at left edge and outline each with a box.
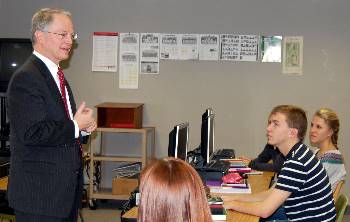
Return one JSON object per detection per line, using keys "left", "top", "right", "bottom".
{"left": 0, "top": 38, "right": 33, "bottom": 93}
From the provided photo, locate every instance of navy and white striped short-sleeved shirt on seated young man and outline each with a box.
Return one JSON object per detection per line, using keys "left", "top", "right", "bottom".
{"left": 275, "top": 143, "right": 336, "bottom": 222}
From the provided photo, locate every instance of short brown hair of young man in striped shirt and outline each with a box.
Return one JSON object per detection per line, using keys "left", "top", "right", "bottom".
{"left": 270, "top": 105, "right": 307, "bottom": 141}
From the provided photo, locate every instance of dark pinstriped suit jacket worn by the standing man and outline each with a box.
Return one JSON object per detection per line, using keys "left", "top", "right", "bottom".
{"left": 8, "top": 55, "right": 82, "bottom": 217}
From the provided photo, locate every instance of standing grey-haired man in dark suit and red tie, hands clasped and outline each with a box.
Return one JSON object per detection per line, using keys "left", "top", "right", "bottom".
{"left": 8, "top": 9, "right": 96, "bottom": 222}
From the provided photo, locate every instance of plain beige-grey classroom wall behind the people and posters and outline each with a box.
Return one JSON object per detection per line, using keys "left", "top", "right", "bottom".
{"left": 0, "top": 0, "right": 350, "bottom": 193}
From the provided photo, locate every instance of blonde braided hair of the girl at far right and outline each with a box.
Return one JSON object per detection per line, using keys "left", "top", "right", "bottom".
{"left": 314, "top": 108, "right": 340, "bottom": 147}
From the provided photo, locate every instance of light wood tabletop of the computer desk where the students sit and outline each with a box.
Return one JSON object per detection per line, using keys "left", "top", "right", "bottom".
{"left": 123, "top": 172, "right": 274, "bottom": 222}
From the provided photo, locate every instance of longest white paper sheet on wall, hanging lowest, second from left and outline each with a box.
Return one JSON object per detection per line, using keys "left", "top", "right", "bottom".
{"left": 119, "top": 33, "right": 140, "bottom": 89}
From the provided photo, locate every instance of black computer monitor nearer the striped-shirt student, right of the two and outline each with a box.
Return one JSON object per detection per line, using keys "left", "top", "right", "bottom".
{"left": 200, "top": 114, "right": 215, "bottom": 165}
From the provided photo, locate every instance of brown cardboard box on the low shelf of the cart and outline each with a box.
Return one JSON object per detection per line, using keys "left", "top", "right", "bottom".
{"left": 112, "top": 177, "right": 139, "bottom": 195}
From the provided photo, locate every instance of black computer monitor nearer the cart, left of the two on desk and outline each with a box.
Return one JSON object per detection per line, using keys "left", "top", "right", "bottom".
{"left": 168, "top": 122, "right": 189, "bottom": 161}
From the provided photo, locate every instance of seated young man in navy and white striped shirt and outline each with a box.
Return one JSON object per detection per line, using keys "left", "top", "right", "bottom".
{"left": 223, "top": 105, "right": 336, "bottom": 222}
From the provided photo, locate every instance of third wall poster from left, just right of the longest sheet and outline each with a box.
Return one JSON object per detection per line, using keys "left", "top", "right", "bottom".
{"left": 140, "top": 33, "right": 159, "bottom": 74}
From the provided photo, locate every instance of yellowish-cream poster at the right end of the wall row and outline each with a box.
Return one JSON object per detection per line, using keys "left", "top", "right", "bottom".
{"left": 282, "top": 36, "right": 303, "bottom": 75}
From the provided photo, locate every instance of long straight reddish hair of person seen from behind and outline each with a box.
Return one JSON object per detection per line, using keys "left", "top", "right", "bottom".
{"left": 138, "top": 158, "right": 212, "bottom": 222}
